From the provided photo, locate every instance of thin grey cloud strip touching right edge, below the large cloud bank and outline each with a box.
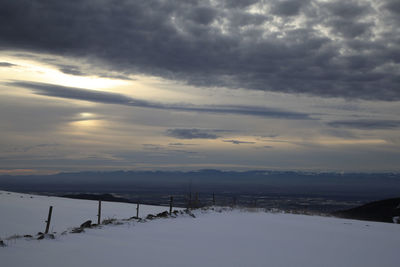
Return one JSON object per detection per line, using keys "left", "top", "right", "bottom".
{"left": 328, "top": 120, "right": 400, "bottom": 130}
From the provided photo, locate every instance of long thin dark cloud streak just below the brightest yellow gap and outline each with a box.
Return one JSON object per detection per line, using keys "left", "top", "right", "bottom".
{"left": 5, "top": 81, "right": 313, "bottom": 120}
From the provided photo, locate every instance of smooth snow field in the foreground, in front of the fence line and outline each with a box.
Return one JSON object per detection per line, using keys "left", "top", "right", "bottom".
{"left": 0, "top": 192, "right": 400, "bottom": 267}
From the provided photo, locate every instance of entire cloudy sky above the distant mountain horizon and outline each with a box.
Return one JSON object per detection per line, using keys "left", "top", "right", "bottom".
{"left": 0, "top": 0, "right": 400, "bottom": 174}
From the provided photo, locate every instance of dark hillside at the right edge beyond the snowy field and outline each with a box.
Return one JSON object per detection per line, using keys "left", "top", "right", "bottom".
{"left": 333, "top": 198, "right": 400, "bottom": 223}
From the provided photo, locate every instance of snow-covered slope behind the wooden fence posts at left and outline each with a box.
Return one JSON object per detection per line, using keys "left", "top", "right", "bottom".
{"left": 0, "top": 191, "right": 173, "bottom": 239}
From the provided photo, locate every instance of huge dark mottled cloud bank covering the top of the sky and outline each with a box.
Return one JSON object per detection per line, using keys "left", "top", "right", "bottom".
{"left": 0, "top": 0, "right": 400, "bottom": 101}
